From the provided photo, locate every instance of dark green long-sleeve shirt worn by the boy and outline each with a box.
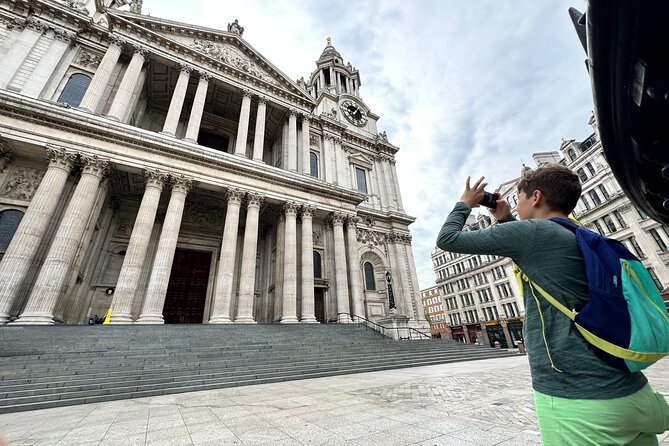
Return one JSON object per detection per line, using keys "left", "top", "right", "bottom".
{"left": 437, "top": 203, "right": 647, "bottom": 399}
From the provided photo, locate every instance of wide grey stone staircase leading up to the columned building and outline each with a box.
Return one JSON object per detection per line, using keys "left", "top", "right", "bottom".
{"left": 0, "top": 324, "right": 516, "bottom": 413}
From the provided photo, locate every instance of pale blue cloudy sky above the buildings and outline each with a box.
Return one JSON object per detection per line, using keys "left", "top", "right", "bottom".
{"left": 142, "top": 0, "right": 593, "bottom": 290}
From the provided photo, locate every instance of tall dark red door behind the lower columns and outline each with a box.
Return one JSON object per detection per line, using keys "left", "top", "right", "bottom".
{"left": 163, "top": 249, "right": 211, "bottom": 324}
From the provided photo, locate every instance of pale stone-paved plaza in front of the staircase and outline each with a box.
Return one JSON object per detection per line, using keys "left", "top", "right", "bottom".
{"left": 0, "top": 356, "right": 669, "bottom": 446}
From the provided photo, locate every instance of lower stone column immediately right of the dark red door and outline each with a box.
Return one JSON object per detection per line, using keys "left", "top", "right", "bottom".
{"left": 209, "top": 189, "right": 244, "bottom": 324}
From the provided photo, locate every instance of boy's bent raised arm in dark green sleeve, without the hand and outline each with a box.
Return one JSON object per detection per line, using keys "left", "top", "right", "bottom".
{"left": 437, "top": 202, "right": 535, "bottom": 259}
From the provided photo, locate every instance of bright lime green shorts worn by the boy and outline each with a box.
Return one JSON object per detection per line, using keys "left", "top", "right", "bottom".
{"left": 534, "top": 384, "right": 669, "bottom": 446}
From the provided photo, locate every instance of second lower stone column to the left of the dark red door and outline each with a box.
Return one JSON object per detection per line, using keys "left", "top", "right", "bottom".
{"left": 111, "top": 171, "right": 167, "bottom": 324}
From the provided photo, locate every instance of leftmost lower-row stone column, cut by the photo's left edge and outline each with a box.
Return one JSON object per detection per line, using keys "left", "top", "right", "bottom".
{"left": 0, "top": 147, "right": 76, "bottom": 324}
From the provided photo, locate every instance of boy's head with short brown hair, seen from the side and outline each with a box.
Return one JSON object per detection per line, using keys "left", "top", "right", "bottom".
{"left": 517, "top": 164, "right": 581, "bottom": 219}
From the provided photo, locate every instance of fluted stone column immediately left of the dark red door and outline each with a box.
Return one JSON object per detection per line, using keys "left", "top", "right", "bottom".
{"left": 137, "top": 175, "right": 192, "bottom": 324}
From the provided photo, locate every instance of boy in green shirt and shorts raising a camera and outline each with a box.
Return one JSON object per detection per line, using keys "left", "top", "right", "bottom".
{"left": 437, "top": 164, "right": 669, "bottom": 446}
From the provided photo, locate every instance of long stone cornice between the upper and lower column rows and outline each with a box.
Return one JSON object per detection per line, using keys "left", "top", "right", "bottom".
{"left": 0, "top": 90, "right": 365, "bottom": 210}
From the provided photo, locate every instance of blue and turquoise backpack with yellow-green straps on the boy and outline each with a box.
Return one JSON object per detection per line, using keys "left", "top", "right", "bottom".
{"left": 516, "top": 218, "right": 669, "bottom": 373}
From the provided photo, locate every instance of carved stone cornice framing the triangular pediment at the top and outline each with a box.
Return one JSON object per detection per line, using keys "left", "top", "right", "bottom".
{"left": 108, "top": 11, "right": 315, "bottom": 111}
